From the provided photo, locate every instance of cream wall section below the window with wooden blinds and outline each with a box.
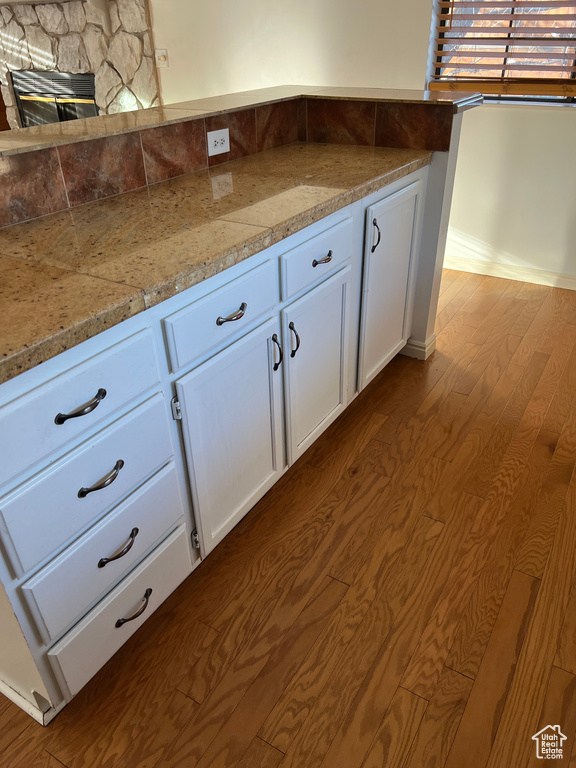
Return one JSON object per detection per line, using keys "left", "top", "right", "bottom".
{"left": 447, "top": 104, "right": 576, "bottom": 288}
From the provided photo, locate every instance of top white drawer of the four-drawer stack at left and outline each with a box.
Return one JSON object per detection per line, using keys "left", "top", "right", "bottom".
{"left": 0, "top": 331, "right": 159, "bottom": 486}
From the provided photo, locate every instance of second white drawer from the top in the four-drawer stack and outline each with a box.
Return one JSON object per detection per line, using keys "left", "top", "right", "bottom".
{"left": 0, "top": 394, "right": 173, "bottom": 576}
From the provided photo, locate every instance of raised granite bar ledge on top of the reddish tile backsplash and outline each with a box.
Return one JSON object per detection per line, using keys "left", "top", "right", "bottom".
{"left": 0, "top": 85, "right": 482, "bottom": 157}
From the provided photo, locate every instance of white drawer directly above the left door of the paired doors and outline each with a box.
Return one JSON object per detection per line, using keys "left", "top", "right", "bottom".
{"left": 164, "top": 261, "right": 278, "bottom": 371}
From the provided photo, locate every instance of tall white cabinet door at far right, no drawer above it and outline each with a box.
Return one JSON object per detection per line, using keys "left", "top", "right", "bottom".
{"left": 358, "top": 181, "right": 423, "bottom": 389}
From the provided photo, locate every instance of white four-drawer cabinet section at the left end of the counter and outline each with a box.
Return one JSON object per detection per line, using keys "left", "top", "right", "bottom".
{"left": 0, "top": 314, "right": 199, "bottom": 723}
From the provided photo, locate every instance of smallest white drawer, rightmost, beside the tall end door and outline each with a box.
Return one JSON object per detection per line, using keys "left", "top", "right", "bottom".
{"left": 281, "top": 219, "right": 353, "bottom": 301}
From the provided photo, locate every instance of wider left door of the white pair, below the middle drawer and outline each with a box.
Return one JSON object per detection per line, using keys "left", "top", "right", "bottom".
{"left": 176, "top": 320, "right": 284, "bottom": 554}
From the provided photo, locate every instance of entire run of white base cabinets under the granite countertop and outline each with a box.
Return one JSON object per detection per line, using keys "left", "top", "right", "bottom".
{"left": 0, "top": 173, "right": 424, "bottom": 722}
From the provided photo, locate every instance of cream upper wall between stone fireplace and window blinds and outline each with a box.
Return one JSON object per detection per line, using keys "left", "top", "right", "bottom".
{"left": 150, "top": 0, "right": 432, "bottom": 104}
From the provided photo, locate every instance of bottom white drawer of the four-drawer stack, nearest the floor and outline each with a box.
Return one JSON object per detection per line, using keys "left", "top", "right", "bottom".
{"left": 48, "top": 527, "right": 192, "bottom": 698}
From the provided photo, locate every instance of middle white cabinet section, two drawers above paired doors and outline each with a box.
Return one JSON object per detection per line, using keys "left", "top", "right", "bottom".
{"left": 173, "top": 211, "right": 359, "bottom": 555}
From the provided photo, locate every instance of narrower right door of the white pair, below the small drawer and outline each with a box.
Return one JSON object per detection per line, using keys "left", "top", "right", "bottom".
{"left": 282, "top": 267, "right": 350, "bottom": 464}
